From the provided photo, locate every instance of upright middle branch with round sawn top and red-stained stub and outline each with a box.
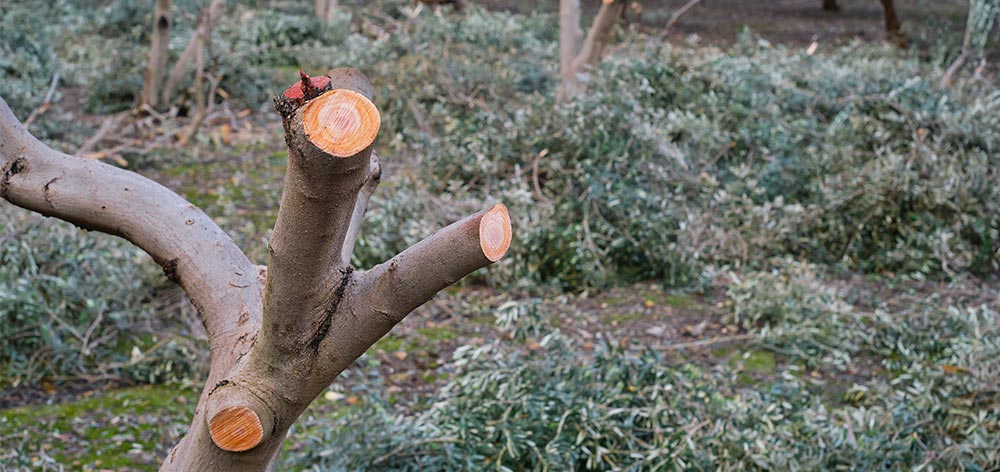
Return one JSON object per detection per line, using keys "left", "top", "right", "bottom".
{"left": 258, "top": 69, "right": 380, "bottom": 359}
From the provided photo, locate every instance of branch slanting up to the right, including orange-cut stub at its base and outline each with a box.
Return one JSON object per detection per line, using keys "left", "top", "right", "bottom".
{"left": 202, "top": 204, "right": 511, "bottom": 465}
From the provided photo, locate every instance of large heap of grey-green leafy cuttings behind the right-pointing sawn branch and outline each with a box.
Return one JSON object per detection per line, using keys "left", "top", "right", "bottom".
{"left": 305, "top": 8, "right": 1000, "bottom": 290}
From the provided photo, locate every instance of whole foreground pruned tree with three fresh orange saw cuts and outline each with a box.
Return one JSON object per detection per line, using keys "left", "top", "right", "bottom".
{"left": 0, "top": 68, "right": 511, "bottom": 471}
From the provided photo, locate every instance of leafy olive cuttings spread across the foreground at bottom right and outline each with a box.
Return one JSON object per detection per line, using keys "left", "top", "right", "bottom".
{"left": 288, "top": 266, "right": 1000, "bottom": 471}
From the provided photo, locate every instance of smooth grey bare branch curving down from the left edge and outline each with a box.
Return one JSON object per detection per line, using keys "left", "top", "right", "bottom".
{"left": 0, "top": 99, "right": 262, "bottom": 358}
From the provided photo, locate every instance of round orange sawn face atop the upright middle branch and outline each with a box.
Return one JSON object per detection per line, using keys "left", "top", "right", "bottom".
{"left": 302, "top": 89, "right": 382, "bottom": 157}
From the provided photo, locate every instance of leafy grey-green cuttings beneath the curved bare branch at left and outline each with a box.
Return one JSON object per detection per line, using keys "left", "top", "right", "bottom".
{"left": 0, "top": 205, "right": 203, "bottom": 388}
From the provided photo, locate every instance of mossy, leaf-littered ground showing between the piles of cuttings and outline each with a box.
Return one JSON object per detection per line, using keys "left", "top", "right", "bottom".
{"left": 0, "top": 0, "right": 1000, "bottom": 470}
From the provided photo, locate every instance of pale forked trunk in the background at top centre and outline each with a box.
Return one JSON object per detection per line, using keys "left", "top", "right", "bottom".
{"left": 559, "top": 0, "right": 626, "bottom": 100}
